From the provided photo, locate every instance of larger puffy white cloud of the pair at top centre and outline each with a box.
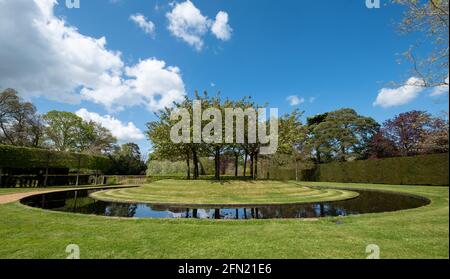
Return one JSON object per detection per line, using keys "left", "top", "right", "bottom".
{"left": 166, "top": 0, "right": 210, "bottom": 50}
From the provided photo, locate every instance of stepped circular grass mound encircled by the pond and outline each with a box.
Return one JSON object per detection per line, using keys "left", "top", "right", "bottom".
{"left": 92, "top": 180, "right": 358, "bottom": 205}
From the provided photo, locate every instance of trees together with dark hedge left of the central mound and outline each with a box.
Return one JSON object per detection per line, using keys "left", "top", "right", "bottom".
{"left": 0, "top": 89, "right": 146, "bottom": 175}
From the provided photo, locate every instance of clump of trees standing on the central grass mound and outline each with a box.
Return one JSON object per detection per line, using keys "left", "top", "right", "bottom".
{"left": 147, "top": 92, "right": 299, "bottom": 182}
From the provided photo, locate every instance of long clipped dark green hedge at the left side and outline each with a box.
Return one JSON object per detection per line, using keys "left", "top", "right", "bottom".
{"left": 0, "top": 145, "right": 109, "bottom": 171}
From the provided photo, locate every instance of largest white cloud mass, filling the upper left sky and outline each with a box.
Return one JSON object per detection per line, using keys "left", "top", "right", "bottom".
{"left": 0, "top": 0, "right": 185, "bottom": 111}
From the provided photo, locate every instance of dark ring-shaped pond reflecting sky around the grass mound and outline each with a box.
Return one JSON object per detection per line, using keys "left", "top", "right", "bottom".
{"left": 21, "top": 189, "right": 430, "bottom": 219}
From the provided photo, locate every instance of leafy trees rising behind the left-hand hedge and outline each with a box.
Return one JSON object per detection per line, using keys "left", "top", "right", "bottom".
{"left": 0, "top": 89, "right": 146, "bottom": 174}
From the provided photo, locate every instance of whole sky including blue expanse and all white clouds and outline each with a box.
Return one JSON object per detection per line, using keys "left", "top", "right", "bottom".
{"left": 0, "top": 0, "right": 448, "bottom": 154}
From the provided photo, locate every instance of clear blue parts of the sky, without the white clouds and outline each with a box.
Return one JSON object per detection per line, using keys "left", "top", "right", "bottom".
{"left": 0, "top": 0, "right": 448, "bottom": 154}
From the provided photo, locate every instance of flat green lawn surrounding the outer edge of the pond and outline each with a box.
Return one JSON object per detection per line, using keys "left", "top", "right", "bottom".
{"left": 0, "top": 182, "right": 449, "bottom": 259}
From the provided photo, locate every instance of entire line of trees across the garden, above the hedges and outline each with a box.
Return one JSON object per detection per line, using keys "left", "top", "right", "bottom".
{"left": 0, "top": 89, "right": 449, "bottom": 179}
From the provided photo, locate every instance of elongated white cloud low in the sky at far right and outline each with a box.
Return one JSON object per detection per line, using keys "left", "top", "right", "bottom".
{"left": 373, "top": 77, "right": 425, "bottom": 108}
